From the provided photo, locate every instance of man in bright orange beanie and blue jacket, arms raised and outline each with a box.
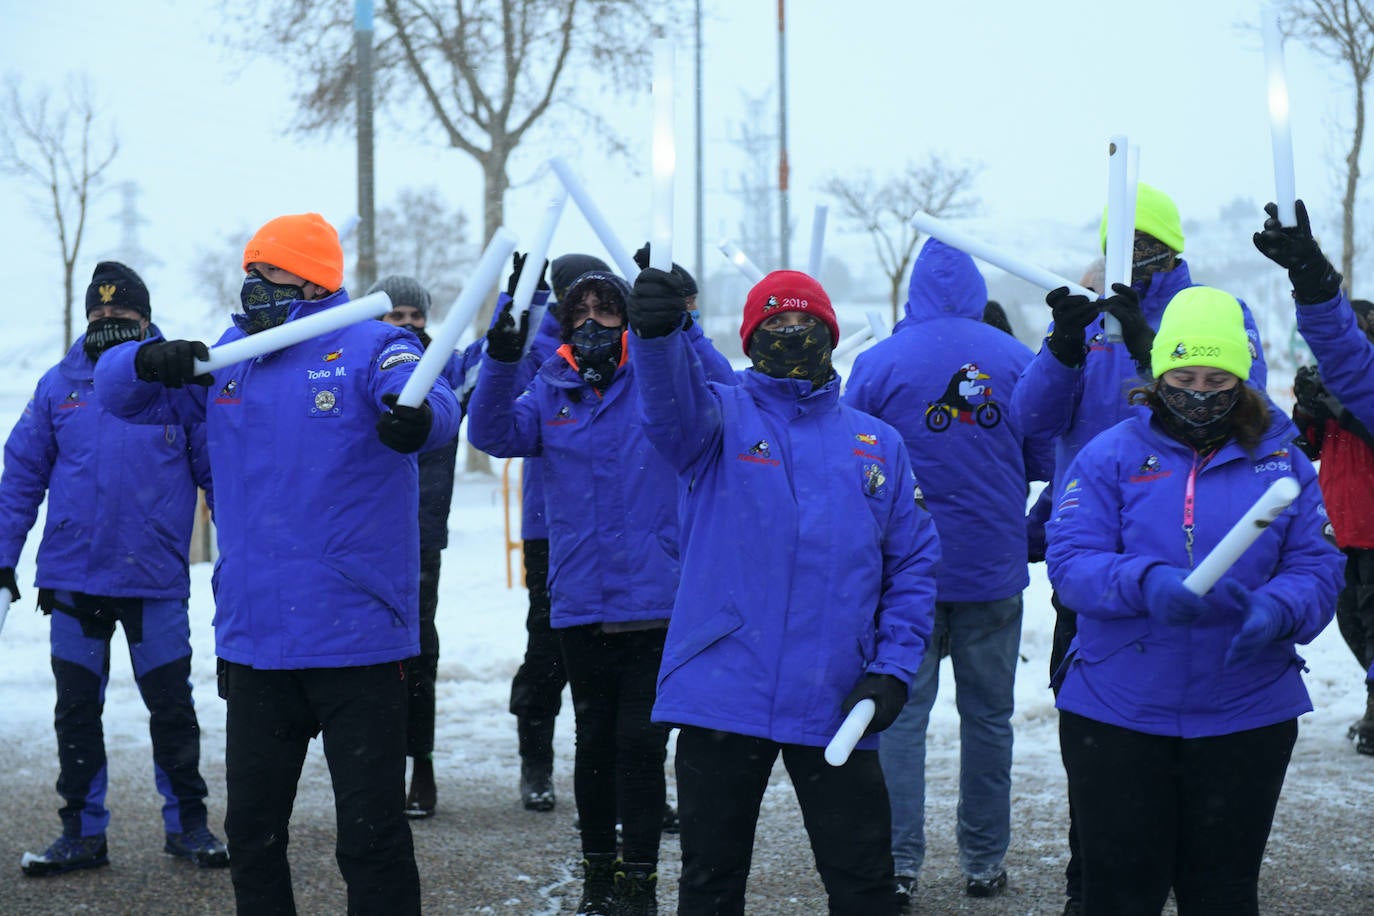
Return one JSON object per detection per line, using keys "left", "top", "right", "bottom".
{"left": 96, "top": 213, "right": 460, "bottom": 913}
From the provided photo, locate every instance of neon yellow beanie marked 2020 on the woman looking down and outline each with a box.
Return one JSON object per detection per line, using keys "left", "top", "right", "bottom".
{"left": 1150, "top": 286, "right": 1253, "bottom": 380}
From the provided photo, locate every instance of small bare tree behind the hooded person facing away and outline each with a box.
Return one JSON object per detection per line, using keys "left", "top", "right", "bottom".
{"left": 820, "top": 154, "right": 982, "bottom": 324}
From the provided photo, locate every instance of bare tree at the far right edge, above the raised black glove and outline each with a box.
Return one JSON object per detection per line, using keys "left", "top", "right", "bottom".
{"left": 1282, "top": 0, "right": 1374, "bottom": 290}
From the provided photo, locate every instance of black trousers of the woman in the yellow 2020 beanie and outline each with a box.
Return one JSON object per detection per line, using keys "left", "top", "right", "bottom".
{"left": 1059, "top": 711, "right": 1297, "bottom": 916}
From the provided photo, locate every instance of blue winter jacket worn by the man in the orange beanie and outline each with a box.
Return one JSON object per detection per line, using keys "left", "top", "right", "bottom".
{"left": 96, "top": 290, "right": 459, "bottom": 669}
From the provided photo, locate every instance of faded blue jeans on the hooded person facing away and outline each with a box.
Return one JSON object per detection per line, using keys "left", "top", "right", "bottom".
{"left": 878, "top": 593, "right": 1021, "bottom": 879}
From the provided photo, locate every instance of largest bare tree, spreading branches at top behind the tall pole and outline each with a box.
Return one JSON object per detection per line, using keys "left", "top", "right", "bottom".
{"left": 224, "top": 0, "right": 665, "bottom": 333}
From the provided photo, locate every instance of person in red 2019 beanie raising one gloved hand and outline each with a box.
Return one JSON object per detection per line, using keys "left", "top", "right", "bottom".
{"left": 631, "top": 269, "right": 940, "bottom": 916}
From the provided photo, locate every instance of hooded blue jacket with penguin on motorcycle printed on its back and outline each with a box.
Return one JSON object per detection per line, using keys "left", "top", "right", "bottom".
{"left": 844, "top": 239, "right": 1054, "bottom": 602}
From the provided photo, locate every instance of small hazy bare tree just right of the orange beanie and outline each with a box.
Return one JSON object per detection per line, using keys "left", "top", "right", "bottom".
{"left": 376, "top": 187, "right": 474, "bottom": 319}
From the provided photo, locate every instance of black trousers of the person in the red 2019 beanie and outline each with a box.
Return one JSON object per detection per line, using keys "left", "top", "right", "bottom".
{"left": 676, "top": 726, "right": 897, "bottom": 916}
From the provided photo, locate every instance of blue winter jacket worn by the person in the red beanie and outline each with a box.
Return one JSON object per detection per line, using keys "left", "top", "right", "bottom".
{"left": 631, "top": 331, "right": 940, "bottom": 748}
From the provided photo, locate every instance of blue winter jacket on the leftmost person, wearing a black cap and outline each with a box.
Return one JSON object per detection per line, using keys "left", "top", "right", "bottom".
{"left": 0, "top": 333, "right": 213, "bottom": 600}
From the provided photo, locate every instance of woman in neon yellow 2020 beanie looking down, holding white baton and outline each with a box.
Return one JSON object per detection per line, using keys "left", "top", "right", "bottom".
{"left": 1047, "top": 287, "right": 1344, "bottom": 915}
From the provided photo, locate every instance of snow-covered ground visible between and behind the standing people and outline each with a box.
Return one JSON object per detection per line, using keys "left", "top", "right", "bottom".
{"left": 0, "top": 324, "right": 1374, "bottom": 913}
